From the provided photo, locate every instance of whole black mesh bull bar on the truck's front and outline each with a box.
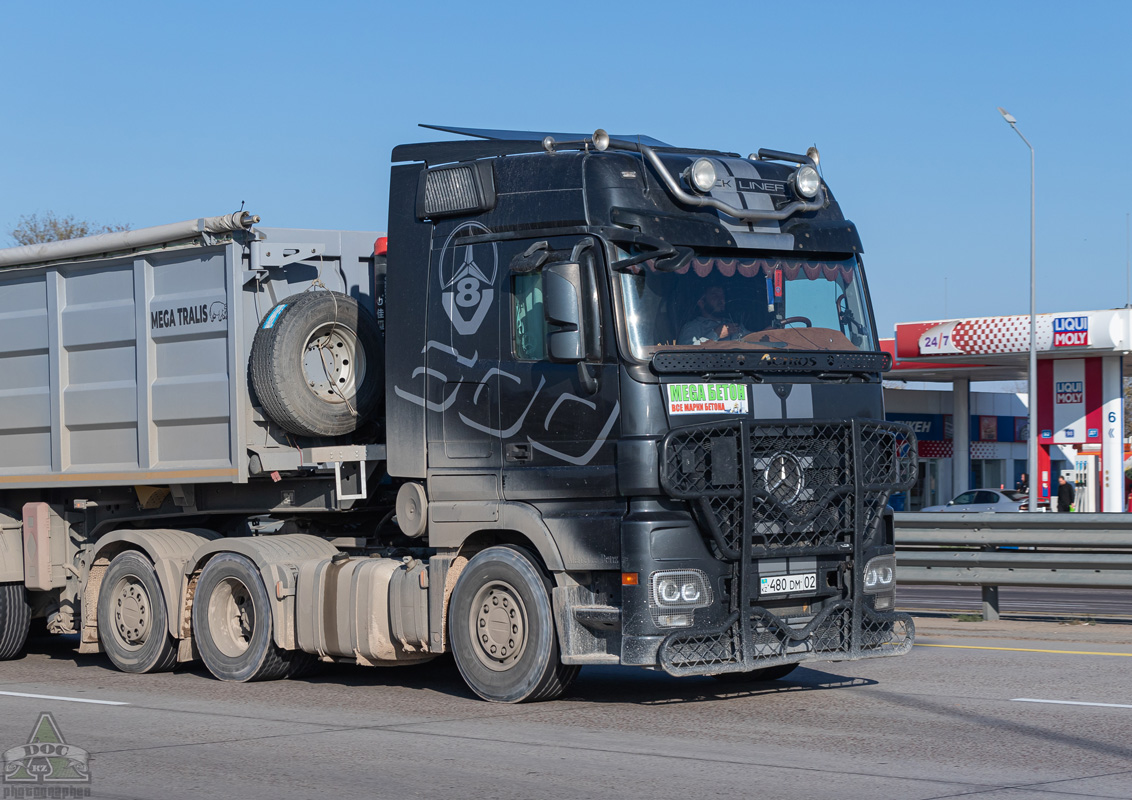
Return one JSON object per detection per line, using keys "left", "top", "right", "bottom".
{"left": 658, "top": 420, "right": 916, "bottom": 674}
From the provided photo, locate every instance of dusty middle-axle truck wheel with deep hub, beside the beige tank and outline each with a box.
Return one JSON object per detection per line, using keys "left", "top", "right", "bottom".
{"left": 192, "top": 553, "right": 294, "bottom": 682}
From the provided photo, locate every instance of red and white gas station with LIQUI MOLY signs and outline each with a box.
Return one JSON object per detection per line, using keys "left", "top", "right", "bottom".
{"left": 882, "top": 308, "right": 1132, "bottom": 511}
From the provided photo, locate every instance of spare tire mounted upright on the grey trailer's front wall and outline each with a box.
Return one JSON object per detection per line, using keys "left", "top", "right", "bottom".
{"left": 249, "top": 292, "right": 385, "bottom": 436}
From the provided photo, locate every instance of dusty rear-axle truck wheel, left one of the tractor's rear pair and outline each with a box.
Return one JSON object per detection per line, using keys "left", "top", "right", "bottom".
{"left": 97, "top": 550, "right": 177, "bottom": 672}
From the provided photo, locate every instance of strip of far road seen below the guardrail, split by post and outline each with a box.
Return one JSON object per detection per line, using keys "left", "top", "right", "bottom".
{"left": 897, "top": 586, "right": 1132, "bottom": 622}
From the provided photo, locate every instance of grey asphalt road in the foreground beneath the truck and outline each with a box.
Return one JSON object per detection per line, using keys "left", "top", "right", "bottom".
{"left": 0, "top": 619, "right": 1132, "bottom": 800}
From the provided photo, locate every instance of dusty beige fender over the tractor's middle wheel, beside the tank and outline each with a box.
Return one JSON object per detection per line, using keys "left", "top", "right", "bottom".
{"left": 187, "top": 533, "right": 338, "bottom": 650}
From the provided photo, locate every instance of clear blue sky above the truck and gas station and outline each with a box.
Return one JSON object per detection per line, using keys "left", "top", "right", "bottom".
{"left": 0, "top": 0, "right": 1132, "bottom": 333}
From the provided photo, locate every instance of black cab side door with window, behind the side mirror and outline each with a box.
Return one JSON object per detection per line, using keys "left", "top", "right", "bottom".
{"left": 498, "top": 236, "right": 620, "bottom": 500}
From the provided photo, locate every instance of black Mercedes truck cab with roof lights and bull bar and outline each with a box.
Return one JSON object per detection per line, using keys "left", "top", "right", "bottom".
{"left": 385, "top": 129, "right": 915, "bottom": 688}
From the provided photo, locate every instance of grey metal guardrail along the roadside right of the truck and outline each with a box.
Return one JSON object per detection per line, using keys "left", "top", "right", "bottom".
{"left": 894, "top": 511, "right": 1132, "bottom": 619}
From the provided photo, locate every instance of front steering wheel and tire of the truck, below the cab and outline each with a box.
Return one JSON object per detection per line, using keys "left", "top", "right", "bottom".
{"left": 448, "top": 545, "right": 578, "bottom": 703}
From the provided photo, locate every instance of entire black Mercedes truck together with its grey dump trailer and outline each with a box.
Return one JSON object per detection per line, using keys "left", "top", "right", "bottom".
{"left": 0, "top": 129, "right": 916, "bottom": 703}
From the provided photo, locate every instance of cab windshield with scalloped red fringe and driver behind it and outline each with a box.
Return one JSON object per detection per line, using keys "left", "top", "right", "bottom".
{"left": 618, "top": 249, "right": 877, "bottom": 360}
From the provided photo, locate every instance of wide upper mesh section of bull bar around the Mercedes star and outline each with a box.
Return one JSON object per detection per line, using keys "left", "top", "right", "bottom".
{"left": 661, "top": 421, "right": 916, "bottom": 560}
